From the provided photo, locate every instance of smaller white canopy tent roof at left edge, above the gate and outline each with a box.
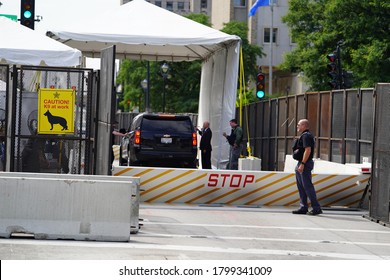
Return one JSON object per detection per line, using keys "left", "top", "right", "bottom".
{"left": 0, "top": 17, "right": 81, "bottom": 66}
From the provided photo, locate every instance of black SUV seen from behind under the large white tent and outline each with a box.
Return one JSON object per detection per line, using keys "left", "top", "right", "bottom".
{"left": 122, "top": 113, "right": 197, "bottom": 168}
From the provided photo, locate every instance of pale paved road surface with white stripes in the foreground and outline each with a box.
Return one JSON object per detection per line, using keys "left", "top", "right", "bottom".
{"left": 0, "top": 204, "right": 390, "bottom": 260}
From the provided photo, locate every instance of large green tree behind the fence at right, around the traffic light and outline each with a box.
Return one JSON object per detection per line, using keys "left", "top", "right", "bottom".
{"left": 281, "top": 0, "right": 390, "bottom": 90}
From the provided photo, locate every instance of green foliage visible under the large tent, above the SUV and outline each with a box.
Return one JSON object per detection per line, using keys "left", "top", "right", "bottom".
{"left": 117, "top": 60, "right": 201, "bottom": 113}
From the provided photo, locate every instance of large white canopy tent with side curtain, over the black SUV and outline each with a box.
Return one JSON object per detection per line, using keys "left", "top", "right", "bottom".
{"left": 47, "top": 0, "right": 240, "bottom": 168}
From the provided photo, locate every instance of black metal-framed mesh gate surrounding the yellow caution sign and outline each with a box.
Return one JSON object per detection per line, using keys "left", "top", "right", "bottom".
{"left": 7, "top": 65, "right": 97, "bottom": 174}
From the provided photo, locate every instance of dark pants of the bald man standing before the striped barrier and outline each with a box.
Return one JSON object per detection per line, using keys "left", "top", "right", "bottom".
{"left": 295, "top": 160, "right": 321, "bottom": 211}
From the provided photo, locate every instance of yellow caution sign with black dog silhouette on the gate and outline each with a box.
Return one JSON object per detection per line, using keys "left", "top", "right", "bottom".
{"left": 38, "top": 88, "right": 76, "bottom": 134}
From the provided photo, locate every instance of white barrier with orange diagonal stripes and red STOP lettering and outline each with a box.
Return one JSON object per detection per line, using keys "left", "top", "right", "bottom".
{"left": 113, "top": 163, "right": 370, "bottom": 208}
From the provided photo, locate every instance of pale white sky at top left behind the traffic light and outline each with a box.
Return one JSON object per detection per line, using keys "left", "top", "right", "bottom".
{"left": 0, "top": 0, "right": 120, "bottom": 33}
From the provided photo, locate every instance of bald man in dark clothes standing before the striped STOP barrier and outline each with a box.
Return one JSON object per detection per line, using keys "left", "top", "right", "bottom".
{"left": 292, "top": 119, "right": 322, "bottom": 215}
